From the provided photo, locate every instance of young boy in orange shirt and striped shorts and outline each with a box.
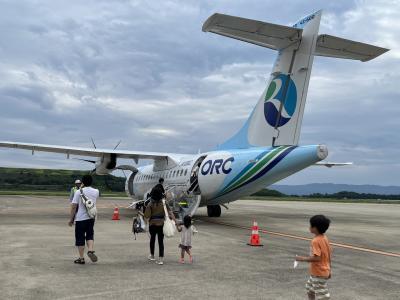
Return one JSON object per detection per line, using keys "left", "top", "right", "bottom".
{"left": 296, "top": 215, "right": 331, "bottom": 300}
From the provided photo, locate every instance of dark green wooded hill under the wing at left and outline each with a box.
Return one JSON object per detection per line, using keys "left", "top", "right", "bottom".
{"left": 0, "top": 168, "right": 125, "bottom": 192}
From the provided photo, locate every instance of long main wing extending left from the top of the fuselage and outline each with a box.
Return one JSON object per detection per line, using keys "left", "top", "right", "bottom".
{"left": 0, "top": 141, "right": 182, "bottom": 163}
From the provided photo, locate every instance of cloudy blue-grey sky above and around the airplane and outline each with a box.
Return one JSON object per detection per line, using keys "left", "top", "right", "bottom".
{"left": 0, "top": 0, "right": 400, "bottom": 185}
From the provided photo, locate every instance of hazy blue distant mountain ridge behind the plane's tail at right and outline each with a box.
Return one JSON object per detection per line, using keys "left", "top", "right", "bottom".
{"left": 268, "top": 183, "right": 400, "bottom": 196}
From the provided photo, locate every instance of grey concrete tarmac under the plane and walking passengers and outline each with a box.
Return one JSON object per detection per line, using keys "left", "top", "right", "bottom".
{"left": 0, "top": 196, "right": 400, "bottom": 300}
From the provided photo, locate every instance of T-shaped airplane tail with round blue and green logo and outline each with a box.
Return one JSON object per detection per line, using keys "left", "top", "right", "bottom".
{"left": 203, "top": 10, "right": 387, "bottom": 149}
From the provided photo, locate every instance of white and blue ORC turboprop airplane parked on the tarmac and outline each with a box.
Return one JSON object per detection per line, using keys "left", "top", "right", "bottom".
{"left": 0, "top": 11, "right": 388, "bottom": 217}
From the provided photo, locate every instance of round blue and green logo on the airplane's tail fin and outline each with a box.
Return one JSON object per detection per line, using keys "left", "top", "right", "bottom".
{"left": 264, "top": 74, "right": 297, "bottom": 127}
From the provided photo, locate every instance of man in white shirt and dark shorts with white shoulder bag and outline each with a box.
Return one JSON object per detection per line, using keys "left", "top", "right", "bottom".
{"left": 68, "top": 175, "right": 99, "bottom": 265}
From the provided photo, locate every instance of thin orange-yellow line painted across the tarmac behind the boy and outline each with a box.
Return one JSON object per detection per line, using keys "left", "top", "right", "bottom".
{"left": 202, "top": 220, "right": 400, "bottom": 258}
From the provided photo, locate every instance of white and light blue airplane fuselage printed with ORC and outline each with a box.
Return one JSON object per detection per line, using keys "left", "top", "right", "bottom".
{"left": 126, "top": 145, "right": 328, "bottom": 206}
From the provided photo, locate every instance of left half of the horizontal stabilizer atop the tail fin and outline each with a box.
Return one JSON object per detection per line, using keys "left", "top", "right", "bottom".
{"left": 202, "top": 13, "right": 302, "bottom": 50}
